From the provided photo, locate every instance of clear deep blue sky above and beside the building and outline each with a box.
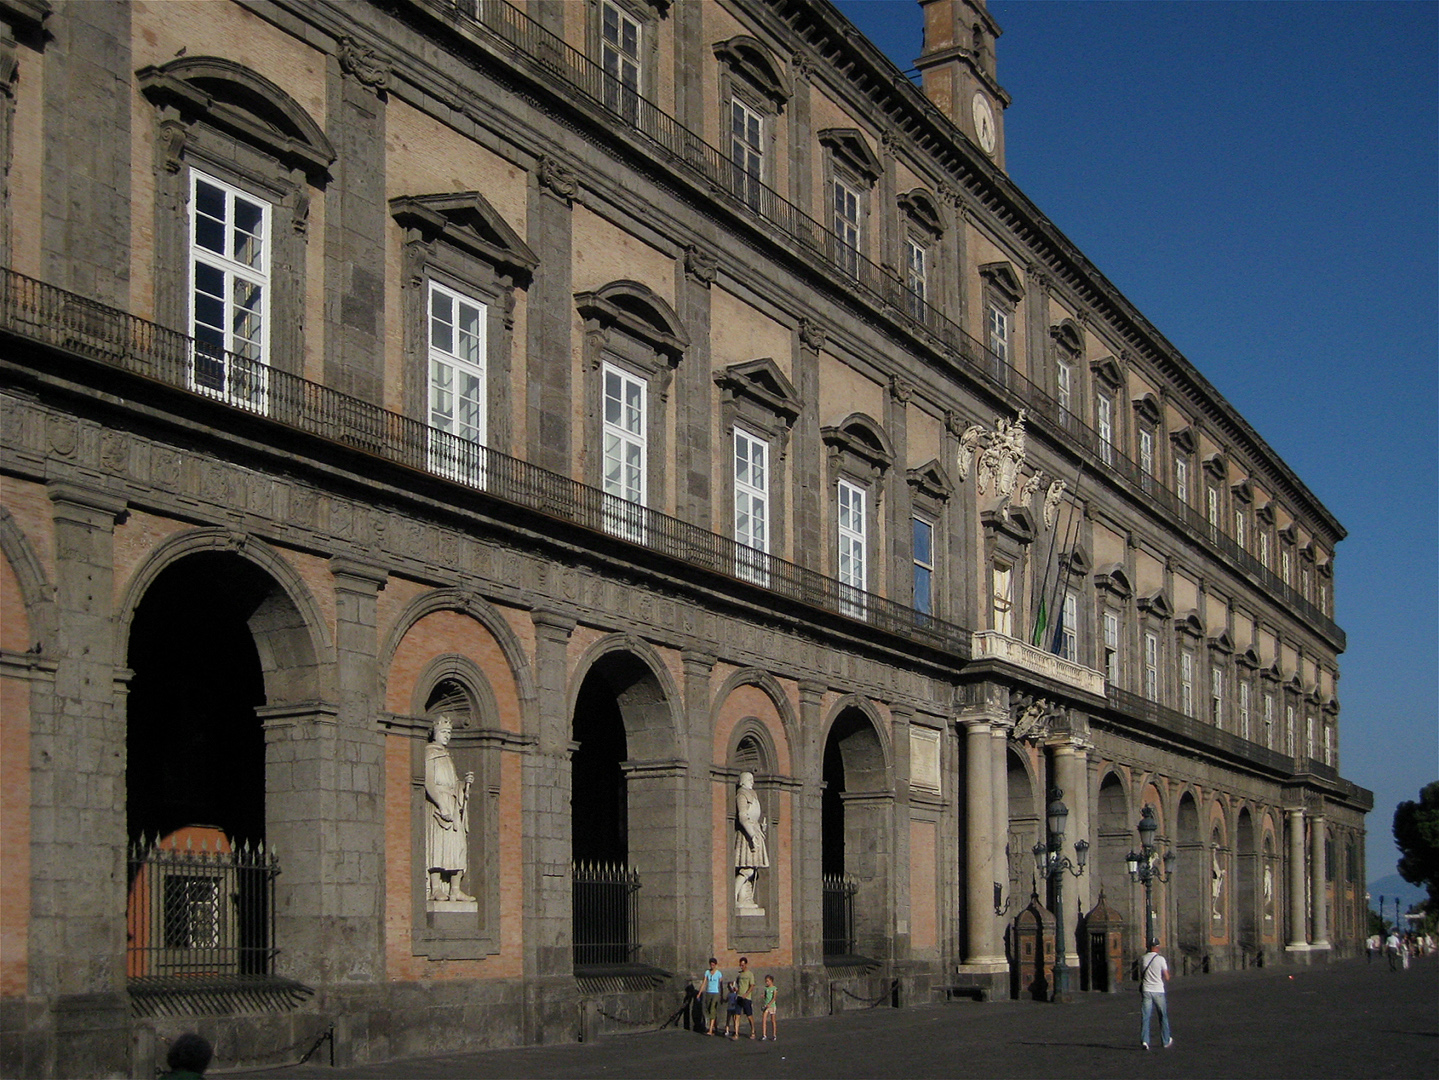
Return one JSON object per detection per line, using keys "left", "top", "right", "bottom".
{"left": 837, "top": 0, "right": 1439, "bottom": 880}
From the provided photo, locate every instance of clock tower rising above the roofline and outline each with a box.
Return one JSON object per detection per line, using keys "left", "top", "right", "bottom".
{"left": 914, "top": 0, "right": 1009, "bottom": 168}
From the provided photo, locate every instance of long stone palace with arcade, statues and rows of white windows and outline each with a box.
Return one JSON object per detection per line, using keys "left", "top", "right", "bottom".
{"left": 0, "top": 0, "right": 1371, "bottom": 1076}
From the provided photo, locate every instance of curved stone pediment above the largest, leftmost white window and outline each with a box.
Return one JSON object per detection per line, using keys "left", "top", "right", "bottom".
{"left": 135, "top": 56, "right": 337, "bottom": 186}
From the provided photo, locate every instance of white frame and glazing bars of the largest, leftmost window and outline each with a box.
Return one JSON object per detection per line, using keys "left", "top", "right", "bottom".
{"left": 187, "top": 168, "right": 273, "bottom": 413}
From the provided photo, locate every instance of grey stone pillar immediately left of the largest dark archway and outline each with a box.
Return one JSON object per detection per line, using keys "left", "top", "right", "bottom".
{"left": 42, "top": 482, "right": 130, "bottom": 1076}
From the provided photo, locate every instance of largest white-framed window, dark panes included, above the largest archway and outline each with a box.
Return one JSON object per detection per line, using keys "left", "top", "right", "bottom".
{"left": 190, "top": 173, "right": 271, "bottom": 410}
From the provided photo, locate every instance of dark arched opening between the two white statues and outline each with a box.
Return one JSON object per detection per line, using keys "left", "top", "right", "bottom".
{"left": 570, "top": 651, "right": 679, "bottom": 971}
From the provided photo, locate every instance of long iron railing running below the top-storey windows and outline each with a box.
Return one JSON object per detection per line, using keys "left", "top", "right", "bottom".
{"left": 443, "top": 0, "right": 1345, "bottom": 650}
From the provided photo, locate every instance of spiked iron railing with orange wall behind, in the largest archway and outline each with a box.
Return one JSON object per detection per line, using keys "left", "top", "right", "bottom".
{"left": 125, "top": 838, "right": 279, "bottom": 985}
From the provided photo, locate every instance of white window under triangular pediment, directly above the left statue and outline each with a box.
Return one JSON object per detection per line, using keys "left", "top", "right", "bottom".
{"left": 429, "top": 282, "right": 488, "bottom": 483}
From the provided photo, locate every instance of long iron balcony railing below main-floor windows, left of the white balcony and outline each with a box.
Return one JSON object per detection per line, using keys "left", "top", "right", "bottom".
{"left": 0, "top": 270, "right": 970, "bottom": 657}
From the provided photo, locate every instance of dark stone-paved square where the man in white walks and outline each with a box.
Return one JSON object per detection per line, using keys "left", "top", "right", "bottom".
{"left": 245, "top": 958, "right": 1439, "bottom": 1080}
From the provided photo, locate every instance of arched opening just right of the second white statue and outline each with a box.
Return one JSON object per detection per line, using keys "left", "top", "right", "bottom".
{"left": 820, "top": 706, "right": 894, "bottom": 959}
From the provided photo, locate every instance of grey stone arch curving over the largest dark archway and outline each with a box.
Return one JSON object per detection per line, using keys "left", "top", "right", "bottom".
{"left": 115, "top": 528, "right": 335, "bottom": 708}
